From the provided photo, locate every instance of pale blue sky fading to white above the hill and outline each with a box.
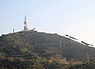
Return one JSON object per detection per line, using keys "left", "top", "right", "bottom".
{"left": 0, "top": 0, "right": 95, "bottom": 47}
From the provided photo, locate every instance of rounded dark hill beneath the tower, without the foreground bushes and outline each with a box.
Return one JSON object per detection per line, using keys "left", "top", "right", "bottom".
{"left": 0, "top": 31, "right": 95, "bottom": 61}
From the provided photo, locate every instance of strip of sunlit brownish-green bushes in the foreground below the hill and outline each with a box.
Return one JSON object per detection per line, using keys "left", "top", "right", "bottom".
{"left": 0, "top": 57, "right": 95, "bottom": 69}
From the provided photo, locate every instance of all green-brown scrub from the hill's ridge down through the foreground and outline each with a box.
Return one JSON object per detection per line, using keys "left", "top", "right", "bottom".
{"left": 0, "top": 31, "right": 95, "bottom": 69}
